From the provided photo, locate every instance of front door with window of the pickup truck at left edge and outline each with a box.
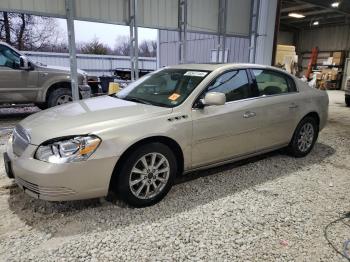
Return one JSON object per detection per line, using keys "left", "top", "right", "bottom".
{"left": 0, "top": 44, "right": 38, "bottom": 103}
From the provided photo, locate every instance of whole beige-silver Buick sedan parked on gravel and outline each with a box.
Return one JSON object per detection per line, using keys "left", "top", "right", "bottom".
{"left": 4, "top": 64, "right": 328, "bottom": 207}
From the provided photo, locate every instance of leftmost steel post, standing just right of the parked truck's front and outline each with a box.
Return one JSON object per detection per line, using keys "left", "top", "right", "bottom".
{"left": 65, "top": 0, "right": 79, "bottom": 100}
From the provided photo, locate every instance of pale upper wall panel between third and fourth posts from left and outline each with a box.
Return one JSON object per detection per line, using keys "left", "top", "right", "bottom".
{"left": 187, "top": 0, "right": 219, "bottom": 33}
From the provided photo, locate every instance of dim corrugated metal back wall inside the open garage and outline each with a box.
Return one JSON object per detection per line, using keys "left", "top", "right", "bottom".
{"left": 297, "top": 25, "right": 350, "bottom": 52}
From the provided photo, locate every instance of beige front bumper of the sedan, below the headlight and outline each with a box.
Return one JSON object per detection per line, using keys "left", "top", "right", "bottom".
{"left": 6, "top": 142, "right": 117, "bottom": 201}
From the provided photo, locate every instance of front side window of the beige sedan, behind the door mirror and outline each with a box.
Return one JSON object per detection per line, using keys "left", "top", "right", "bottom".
{"left": 207, "top": 70, "right": 250, "bottom": 102}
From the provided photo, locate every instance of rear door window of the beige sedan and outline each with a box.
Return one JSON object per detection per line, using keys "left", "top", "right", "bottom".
{"left": 252, "top": 69, "right": 296, "bottom": 96}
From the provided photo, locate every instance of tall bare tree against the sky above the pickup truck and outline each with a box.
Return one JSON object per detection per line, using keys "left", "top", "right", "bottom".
{"left": 0, "top": 12, "right": 63, "bottom": 50}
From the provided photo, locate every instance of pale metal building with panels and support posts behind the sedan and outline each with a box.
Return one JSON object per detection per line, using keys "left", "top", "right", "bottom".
{"left": 0, "top": 0, "right": 277, "bottom": 99}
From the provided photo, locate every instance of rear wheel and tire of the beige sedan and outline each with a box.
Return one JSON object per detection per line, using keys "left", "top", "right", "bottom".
{"left": 287, "top": 116, "right": 319, "bottom": 157}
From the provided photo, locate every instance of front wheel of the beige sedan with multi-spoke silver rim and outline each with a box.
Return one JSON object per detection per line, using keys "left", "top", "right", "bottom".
{"left": 115, "top": 143, "right": 177, "bottom": 207}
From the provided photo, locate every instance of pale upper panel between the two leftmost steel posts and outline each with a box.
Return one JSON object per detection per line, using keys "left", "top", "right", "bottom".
{"left": 75, "top": 0, "right": 125, "bottom": 24}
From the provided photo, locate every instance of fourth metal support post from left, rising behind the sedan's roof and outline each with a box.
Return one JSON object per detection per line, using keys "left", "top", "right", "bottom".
{"left": 216, "top": 0, "right": 227, "bottom": 63}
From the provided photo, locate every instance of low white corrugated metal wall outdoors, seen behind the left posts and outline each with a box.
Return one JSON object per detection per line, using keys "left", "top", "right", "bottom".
{"left": 24, "top": 52, "right": 157, "bottom": 76}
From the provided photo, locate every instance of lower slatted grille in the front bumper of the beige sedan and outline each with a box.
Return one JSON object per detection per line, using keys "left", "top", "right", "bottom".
{"left": 15, "top": 177, "right": 75, "bottom": 197}
